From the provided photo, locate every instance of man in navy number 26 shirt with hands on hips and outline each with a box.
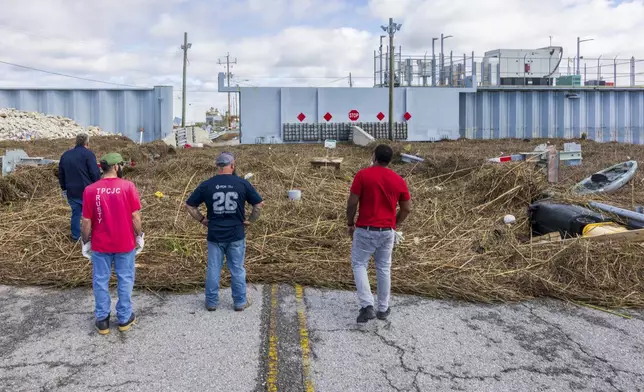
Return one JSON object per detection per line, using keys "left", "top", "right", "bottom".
{"left": 186, "top": 152, "right": 264, "bottom": 312}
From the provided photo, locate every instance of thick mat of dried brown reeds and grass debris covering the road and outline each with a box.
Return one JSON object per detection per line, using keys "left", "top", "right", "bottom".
{"left": 0, "top": 136, "right": 644, "bottom": 307}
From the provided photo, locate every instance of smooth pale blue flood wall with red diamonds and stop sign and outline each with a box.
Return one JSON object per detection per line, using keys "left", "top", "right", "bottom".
{"left": 239, "top": 87, "right": 474, "bottom": 144}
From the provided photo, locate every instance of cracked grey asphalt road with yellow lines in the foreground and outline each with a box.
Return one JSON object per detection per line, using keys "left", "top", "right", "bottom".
{"left": 0, "top": 285, "right": 644, "bottom": 392}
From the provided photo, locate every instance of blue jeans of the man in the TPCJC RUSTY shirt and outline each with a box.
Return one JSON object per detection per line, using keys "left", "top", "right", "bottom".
{"left": 92, "top": 250, "right": 135, "bottom": 324}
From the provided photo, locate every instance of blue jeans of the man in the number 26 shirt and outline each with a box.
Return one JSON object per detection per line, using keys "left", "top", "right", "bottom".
{"left": 206, "top": 239, "right": 246, "bottom": 307}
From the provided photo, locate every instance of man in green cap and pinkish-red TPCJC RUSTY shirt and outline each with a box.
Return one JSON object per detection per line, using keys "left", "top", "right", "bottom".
{"left": 81, "top": 153, "right": 144, "bottom": 335}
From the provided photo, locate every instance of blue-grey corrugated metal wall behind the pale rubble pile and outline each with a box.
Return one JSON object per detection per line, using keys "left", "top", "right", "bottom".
{"left": 0, "top": 86, "right": 172, "bottom": 141}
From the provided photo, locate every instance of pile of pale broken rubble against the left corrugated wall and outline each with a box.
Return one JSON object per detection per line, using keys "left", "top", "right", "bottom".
{"left": 0, "top": 108, "right": 108, "bottom": 140}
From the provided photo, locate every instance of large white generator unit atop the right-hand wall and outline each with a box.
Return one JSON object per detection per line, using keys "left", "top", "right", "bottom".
{"left": 481, "top": 46, "right": 563, "bottom": 86}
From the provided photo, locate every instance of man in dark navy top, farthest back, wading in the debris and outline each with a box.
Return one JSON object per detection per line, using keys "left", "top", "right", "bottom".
{"left": 58, "top": 133, "right": 101, "bottom": 242}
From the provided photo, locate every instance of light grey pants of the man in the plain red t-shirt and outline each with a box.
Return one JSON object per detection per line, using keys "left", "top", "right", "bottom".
{"left": 351, "top": 228, "right": 395, "bottom": 312}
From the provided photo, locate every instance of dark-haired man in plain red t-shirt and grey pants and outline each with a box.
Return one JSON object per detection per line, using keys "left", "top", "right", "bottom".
{"left": 347, "top": 144, "right": 411, "bottom": 323}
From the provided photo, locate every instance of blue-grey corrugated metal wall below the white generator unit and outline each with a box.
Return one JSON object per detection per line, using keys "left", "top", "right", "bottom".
{"left": 460, "top": 88, "right": 644, "bottom": 144}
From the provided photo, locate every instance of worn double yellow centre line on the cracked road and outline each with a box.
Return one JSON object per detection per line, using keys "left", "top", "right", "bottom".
{"left": 266, "top": 284, "right": 315, "bottom": 392}
